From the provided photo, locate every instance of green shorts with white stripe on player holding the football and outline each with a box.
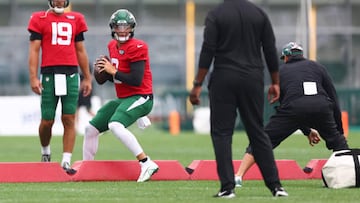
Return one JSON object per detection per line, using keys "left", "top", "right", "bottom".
{"left": 90, "top": 95, "right": 153, "bottom": 132}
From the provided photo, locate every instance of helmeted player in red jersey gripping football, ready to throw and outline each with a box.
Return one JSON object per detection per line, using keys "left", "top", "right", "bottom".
{"left": 83, "top": 9, "right": 159, "bottom": 182}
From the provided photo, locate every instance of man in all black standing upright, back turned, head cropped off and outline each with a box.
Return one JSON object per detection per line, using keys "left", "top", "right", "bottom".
{"left": 189, "top": 0, "right": 288, "bottom": 198}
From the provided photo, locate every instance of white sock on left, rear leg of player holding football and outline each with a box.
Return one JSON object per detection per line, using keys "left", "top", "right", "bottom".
{"left": 83, "top": 124, "right": 100, "bottom": 160}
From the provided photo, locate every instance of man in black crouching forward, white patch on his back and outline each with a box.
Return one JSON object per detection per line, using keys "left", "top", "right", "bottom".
{"left": 235, "top": 42, "right": 349, "bottom": 186}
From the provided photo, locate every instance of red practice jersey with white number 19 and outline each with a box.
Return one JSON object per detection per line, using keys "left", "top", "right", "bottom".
{"left": 28, "top": 11, "right": 88, "bottom": 67}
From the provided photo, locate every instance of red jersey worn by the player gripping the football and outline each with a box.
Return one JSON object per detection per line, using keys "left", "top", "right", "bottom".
{"left": 108, "top": 38, "right": 152, "bottom": 98}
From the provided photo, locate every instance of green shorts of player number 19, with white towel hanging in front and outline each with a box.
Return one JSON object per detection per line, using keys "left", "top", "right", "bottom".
{"left": 41, "top": 73, "right": 79, "bottom": 120}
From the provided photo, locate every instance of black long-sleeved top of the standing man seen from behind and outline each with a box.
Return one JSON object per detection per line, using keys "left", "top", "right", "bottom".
{"left": 199, "top": 0, "right": 279, "bottom": 73}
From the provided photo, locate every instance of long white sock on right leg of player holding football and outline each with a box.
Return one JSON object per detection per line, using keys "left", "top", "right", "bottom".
{"left": 109, "top": 122, "right": 143, "bottom": 157}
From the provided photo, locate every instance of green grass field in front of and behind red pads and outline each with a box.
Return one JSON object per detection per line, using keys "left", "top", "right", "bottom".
{"left": 0, "top": 123, "right": 360, "bottom": 203}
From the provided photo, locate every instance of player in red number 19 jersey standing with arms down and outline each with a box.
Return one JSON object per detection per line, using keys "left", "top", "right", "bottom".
{"left": 28, "top": 0, "right": 92, "bottom": 174}
